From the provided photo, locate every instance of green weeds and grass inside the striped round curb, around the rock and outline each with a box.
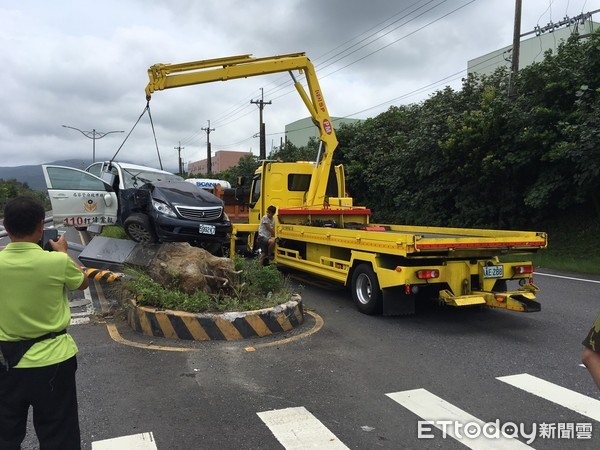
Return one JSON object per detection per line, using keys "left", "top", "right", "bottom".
{"left": 123, "top": 258, "right": 292, "bottom": 313}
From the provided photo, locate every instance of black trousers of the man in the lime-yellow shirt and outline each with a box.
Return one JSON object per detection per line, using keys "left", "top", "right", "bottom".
{"left": 0, "top": 356, "right": 81, "bottom": 450}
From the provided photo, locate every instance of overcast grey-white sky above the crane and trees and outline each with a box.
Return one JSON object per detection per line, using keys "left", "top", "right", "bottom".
{"left": 0, "top": 0, "right": 600, "bottom": 171}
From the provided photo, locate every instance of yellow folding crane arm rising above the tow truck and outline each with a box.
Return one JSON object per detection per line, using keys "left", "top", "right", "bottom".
{"left": 146, "top": 53, "right": 338, "bottom": 207}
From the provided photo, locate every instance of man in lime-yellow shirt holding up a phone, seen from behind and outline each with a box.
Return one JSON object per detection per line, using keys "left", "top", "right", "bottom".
{"left": 0, "top": 197, "right": 88, "bottom": 450}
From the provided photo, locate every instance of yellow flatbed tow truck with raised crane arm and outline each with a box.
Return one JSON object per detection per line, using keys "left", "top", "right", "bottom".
{"left": 146, "top": 53, "right": 547, "bottom": 315}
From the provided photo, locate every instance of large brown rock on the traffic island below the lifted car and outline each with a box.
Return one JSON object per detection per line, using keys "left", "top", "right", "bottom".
{"left": 148, "top": 242, "right": 237, "bottom": 294}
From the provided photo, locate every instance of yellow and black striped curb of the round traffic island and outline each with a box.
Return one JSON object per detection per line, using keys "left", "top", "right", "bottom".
{"left": 127, "top": 295, "right": 304, "bottom": 341}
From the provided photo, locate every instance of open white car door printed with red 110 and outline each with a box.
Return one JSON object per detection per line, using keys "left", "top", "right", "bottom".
{"left": 42, "top": 165, "right": 118, "bottom": 227}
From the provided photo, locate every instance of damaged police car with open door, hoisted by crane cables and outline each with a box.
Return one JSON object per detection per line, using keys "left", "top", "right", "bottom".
{"left": 42, "top": 161, "right": 232, "bottom": 252}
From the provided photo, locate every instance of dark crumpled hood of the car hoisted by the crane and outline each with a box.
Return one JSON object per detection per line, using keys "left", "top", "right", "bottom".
{"left": 142, "top": 181, "right": 223, "bottom": 207}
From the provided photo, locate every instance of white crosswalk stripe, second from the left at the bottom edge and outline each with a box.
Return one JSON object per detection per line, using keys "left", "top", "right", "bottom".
{"left": 256, "top": 407, "right": 348, "bottom": 449}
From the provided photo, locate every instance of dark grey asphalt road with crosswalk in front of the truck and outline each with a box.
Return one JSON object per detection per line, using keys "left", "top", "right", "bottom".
{"left": 5, "top": 230, "right": 600, "bottom": 450}
